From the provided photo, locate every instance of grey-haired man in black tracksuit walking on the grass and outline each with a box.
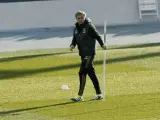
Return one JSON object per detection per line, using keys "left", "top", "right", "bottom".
{"left": 70, "top": 11, "right": 106, "bottom": 102}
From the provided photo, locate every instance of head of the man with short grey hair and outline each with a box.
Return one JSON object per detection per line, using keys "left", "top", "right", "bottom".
{"left": 75, "top": 11, "right": 87, "bottom": 24}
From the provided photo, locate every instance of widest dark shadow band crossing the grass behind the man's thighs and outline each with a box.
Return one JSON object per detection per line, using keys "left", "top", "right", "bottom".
{"left": 0, "top": 52, "right": 160, "bottom": 80}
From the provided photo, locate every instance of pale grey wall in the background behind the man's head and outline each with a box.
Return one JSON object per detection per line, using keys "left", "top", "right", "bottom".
{"left": 0, "top": 0, "right": 160, "bottom": 30}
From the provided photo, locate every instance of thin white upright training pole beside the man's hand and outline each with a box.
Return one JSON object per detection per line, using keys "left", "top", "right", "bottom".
{"left": 102, "top": 20, "right": 107, "bottom": 100}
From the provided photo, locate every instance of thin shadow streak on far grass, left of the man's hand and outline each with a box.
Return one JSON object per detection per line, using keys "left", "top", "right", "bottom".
{"left": 0, "top": 52, "right": 75, "bottom": 62}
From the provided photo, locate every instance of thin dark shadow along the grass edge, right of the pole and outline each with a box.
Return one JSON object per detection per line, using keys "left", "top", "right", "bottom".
{"left": 109, "top": 43, "right": 160, "bottom": 49}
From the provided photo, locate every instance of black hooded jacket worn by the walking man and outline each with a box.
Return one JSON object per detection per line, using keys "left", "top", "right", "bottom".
{"left": 71, "top": 18, "right": 104, "bottom": 56}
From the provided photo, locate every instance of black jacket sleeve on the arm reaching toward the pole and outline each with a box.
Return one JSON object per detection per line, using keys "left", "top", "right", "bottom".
{"left": 89, "top": 24, "right": 104, "bottom": 46}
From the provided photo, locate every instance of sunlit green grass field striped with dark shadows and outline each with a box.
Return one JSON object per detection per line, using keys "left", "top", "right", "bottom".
{"left": 0, "top": 44, "right": 160, "bottom": 120}
